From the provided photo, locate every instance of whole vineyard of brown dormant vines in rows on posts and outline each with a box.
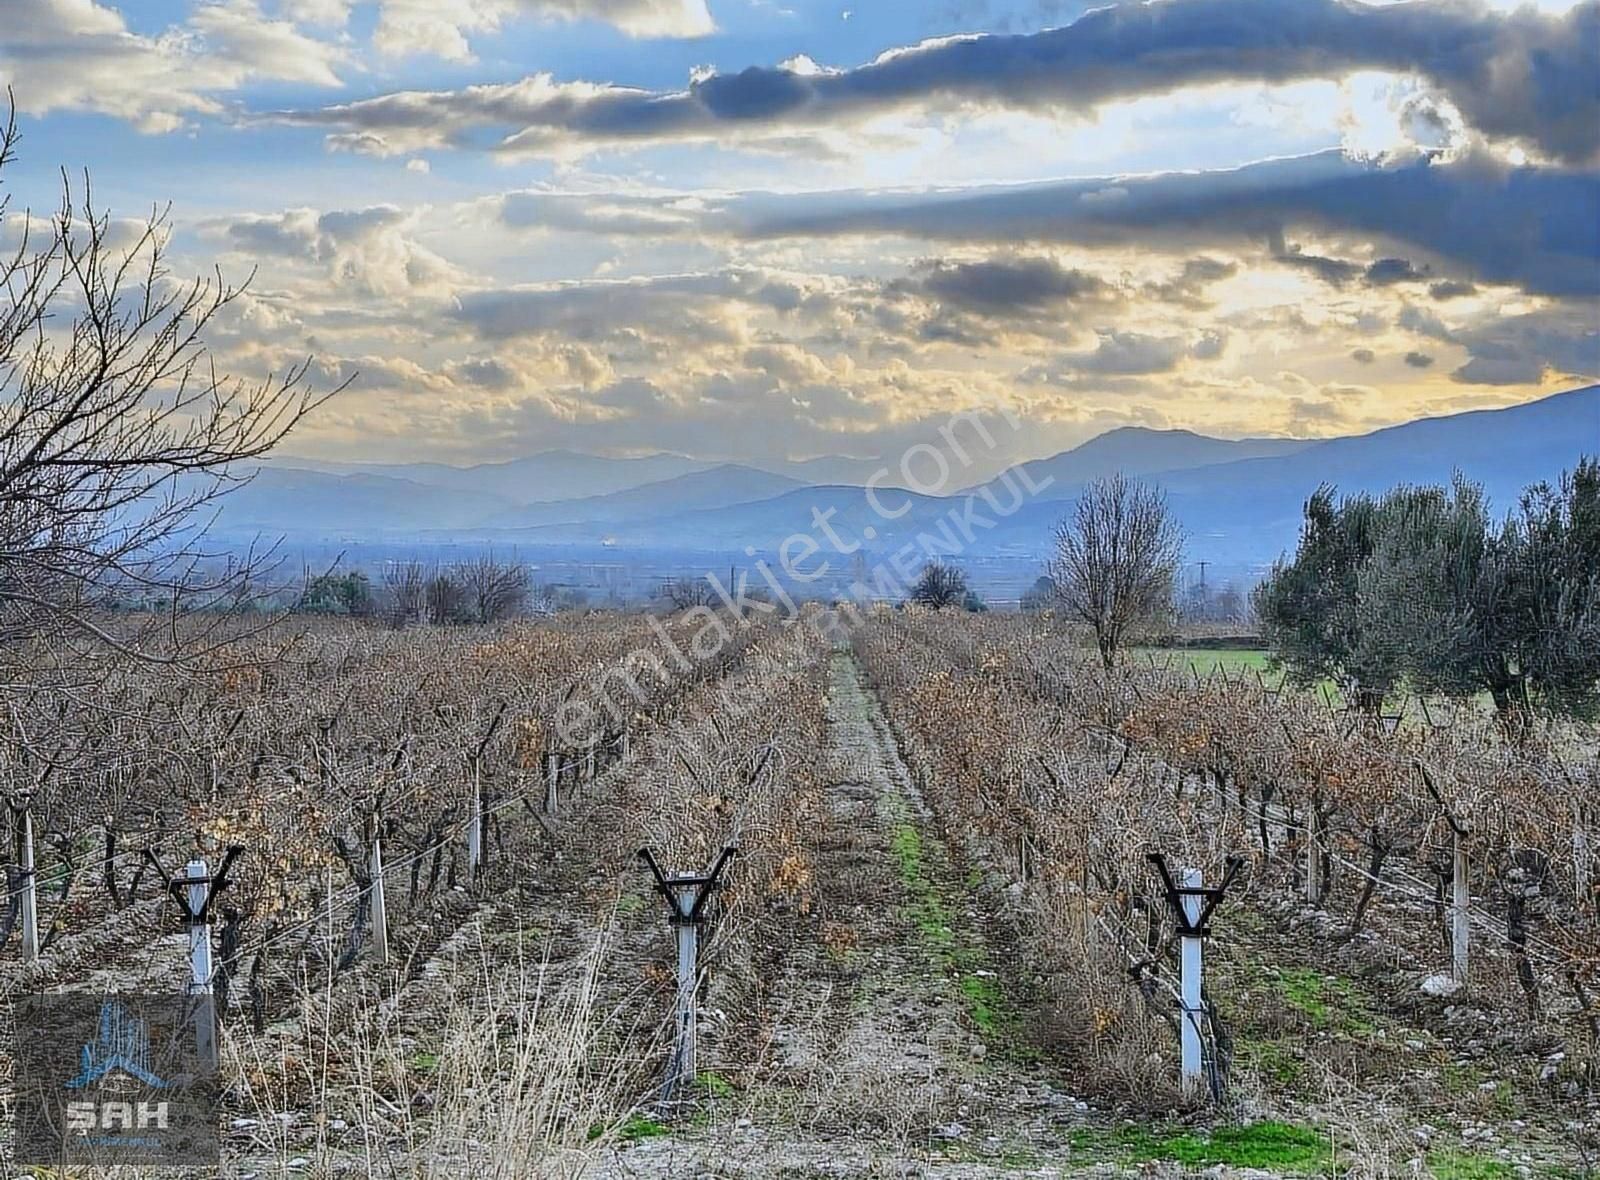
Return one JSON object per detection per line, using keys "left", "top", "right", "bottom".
{"left": 0, "top": 608, "right": 1600, "bottom": 1177}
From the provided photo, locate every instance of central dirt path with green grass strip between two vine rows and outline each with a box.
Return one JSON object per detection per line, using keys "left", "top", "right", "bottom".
{"left": 600, "top": 652, "right": 1083, "bottom": 1180}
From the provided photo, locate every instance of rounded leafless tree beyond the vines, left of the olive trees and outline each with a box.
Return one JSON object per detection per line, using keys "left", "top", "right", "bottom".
{"left": 1050, "top": 473, "right": 1184, "bottom": 668}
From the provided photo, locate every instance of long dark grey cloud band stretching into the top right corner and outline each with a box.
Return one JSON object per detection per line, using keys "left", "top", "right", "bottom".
{"left": 283, "top": 0, "right": 1600, "bottom": 163}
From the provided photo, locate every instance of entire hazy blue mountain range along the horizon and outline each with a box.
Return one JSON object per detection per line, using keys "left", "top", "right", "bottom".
{"left": 228, "top": 385, "right": 1600, "bottom": 568}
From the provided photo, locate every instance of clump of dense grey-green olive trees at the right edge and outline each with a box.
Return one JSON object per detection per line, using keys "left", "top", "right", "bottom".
{"left": 1256, "top": 460, "right": 1600, "bottom": 734}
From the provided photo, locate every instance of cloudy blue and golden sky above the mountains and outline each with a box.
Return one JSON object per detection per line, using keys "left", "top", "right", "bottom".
{"left": 0, "top": 0, "right": 1600, "bottom": 464}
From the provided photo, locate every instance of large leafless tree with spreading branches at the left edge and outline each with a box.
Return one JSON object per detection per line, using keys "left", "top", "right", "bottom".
{"left": 0, "top": 89, "right": 347, "bottom": 680}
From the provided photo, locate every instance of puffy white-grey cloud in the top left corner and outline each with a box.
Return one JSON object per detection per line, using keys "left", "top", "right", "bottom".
{"left": 0, "top": 0, "right": 346, "bottom": 133}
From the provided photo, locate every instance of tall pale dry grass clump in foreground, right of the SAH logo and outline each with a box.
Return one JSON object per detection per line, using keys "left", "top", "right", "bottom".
{"left": 224, "top": 931, "right": 636, "bottom": 1180}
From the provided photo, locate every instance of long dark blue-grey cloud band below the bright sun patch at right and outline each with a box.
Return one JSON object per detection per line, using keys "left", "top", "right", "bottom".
{"left": 739, "top": 152, "right": 1600, "bottom": 296}
